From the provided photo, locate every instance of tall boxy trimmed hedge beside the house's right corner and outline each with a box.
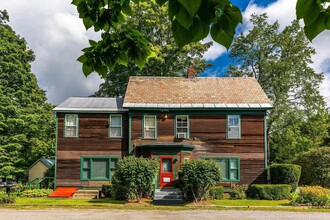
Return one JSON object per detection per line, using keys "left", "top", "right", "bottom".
{"left": 269, "top": 164, "right": 301, "bottom": 192}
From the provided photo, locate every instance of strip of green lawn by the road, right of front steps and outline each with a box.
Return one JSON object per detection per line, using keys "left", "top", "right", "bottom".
{"left": 210, "top": 199, "right": 290, "bottom": 206}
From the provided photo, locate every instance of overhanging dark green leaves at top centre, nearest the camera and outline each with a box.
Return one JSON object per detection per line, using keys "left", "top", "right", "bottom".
{"left": 72, "top": 0, "right": 242, "bottom": 77}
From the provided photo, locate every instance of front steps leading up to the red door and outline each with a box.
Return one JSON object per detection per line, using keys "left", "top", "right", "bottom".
{"left": 154, "top": 188, "right": 183, "bottom": 205}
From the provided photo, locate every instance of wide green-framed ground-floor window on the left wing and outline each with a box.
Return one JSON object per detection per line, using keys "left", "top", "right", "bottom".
{"left": 80, "top": 157, "right": 119, "bottom": 180}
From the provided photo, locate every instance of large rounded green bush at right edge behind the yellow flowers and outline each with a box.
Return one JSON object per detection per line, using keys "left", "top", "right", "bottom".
{"left": 294, "top": 147, "right": 330, "bottom": 187}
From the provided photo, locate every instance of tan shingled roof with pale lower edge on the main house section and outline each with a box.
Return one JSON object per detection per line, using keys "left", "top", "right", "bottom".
{"left": 123, "top": 77, "right": 272, "bottom": 109}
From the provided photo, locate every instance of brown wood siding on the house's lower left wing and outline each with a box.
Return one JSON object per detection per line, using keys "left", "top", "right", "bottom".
{"left": 56, "top": 113, "right": 128, "bottom": 187}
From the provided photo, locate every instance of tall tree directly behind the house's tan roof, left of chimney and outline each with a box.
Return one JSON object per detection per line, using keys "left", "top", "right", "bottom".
{"left": 95, "top": 1, "right": 212, "bottom": 96}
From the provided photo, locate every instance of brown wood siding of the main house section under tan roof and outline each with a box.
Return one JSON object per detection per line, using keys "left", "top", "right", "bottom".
{"left": 131, "top": 114, "right": 266, "bottom": 184}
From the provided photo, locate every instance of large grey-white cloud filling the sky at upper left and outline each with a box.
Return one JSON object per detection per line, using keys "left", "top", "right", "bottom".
{"left": 0, "top": 0, "right": 102, "bottom": 104}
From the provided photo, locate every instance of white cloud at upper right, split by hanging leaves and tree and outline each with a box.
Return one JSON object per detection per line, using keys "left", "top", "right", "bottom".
{"left": 243, "top": 0, "right": 330, "bottom": 107}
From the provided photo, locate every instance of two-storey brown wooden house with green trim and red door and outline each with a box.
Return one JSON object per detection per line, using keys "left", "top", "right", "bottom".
{"left": 54, "top": 69, "right": 271, "bottom": 187}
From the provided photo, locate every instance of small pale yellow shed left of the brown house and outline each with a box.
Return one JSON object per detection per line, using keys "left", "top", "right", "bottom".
{"left": 28, "top": 158, "right": 55, "bottom": 182}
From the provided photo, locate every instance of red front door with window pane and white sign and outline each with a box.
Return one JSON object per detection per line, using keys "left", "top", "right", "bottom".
{"left": 159, "top": 156, "right": 174, "bottom": 187}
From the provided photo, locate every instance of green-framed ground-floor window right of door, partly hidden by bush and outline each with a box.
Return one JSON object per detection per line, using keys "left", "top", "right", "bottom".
{"left": 207, "top": 158, "right": 240, "bottom": 182}
